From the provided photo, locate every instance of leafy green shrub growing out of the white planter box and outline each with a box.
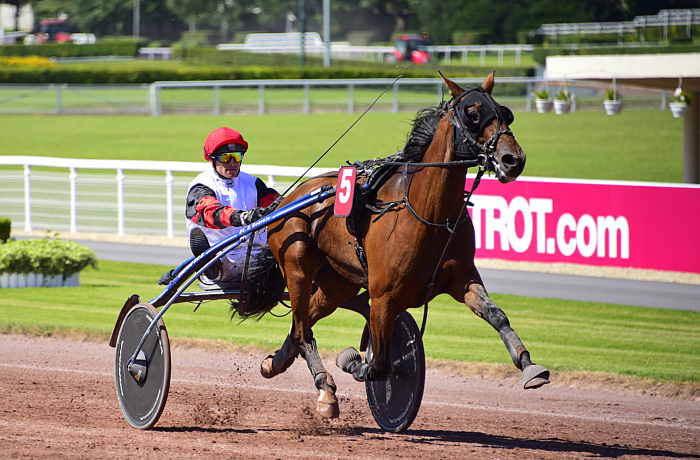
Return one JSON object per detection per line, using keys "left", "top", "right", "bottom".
{"left": 0, "top": 239, "right": 97, "bottom": 278}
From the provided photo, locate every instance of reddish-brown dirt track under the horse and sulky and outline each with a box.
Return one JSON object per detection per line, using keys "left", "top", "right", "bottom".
{"left": 0, "top": 335, "right": 700, "bottom": 459}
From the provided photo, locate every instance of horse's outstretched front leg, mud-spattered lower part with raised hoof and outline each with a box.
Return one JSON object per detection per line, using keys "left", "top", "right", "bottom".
{"left": 464, "top": 283, "right": 549, "bottom": 389}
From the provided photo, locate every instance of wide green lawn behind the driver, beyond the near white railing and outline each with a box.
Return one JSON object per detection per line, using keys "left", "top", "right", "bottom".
{"left": 0, "top": 109, "right": 683, "bottom": 183}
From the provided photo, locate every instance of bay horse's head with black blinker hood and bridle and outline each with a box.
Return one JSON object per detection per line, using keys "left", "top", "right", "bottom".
{"left": 440, "top": 72, "right": 525, "bottom": 183}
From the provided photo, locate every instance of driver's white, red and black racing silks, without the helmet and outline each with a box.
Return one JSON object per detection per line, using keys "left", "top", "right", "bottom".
{"left": 185, "top": 168, "right": 279, "bottom": 277}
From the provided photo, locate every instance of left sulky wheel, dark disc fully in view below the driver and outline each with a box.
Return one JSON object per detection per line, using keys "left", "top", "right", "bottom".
{"left": 114, "top": 303, "right": 170, "bottom": 430}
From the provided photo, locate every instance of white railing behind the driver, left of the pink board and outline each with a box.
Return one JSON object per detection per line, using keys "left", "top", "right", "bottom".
{"left": 0, "top": 156, "right": 329, "bottom": 237}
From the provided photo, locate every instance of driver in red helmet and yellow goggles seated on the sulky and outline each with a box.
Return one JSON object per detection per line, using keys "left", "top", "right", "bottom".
{"left": 185, "top": 127, "right": 279, "bottom": 289}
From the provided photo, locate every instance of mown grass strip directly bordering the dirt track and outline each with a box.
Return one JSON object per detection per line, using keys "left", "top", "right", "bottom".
{"left": 0, "top": 261, "right": 700, "bottom": 382}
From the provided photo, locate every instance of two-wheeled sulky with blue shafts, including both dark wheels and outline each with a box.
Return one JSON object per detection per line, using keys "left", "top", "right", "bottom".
{"left": 109, "top": 181, "right": 425, "bottom": 432}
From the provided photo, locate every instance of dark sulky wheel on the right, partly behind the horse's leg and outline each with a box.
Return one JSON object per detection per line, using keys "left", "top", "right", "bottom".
{"left": 365, "top": 312, "right": 425, "bottom": 433}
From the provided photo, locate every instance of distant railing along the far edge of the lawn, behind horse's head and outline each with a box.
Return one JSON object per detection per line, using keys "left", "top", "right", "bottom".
{"left": 0, "top": 77, "right": 666, "bottom": 117}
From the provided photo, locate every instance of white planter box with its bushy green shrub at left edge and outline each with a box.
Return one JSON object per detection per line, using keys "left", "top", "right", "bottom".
{"left": 0, "top": 238, "right": 97, "bottom": 288}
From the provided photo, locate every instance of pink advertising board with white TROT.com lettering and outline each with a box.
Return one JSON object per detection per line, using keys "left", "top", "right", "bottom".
{"left": 466, "top": 178, "right": 700, "bottom": 273}
